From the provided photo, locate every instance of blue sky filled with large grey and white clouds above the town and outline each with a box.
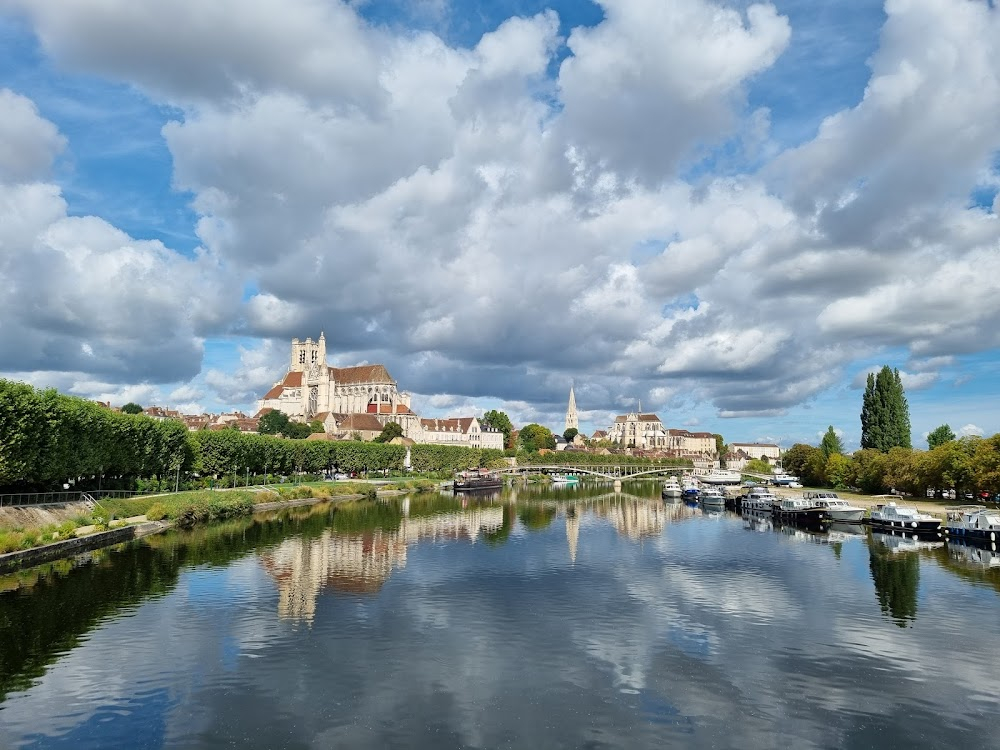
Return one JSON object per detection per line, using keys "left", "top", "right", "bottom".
{"left": 0, "top": 0, "right": 1000, "bottom": 448}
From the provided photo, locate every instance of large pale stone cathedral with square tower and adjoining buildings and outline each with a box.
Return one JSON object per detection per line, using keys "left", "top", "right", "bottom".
{"left": 257, "top": 333, "right": 503, "bottom": 449}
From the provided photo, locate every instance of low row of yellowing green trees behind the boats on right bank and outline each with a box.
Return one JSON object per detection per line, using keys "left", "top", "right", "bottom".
{"left": 782, "top": 434, "right": 1000, "bottom": 497}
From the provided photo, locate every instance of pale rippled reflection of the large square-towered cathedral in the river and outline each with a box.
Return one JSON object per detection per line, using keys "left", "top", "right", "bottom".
{"left": 261, "top": 507, "right": 503, "bottom": 623}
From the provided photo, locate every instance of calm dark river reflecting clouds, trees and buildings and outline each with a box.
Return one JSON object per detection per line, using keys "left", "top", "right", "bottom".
{"left": 0, "top": 483, "right": 1000, "bottom": 750}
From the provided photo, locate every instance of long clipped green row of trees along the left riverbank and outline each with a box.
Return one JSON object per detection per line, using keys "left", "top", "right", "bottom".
{"left": 0, "top": 380, "right": 503, "bottom": 492}
